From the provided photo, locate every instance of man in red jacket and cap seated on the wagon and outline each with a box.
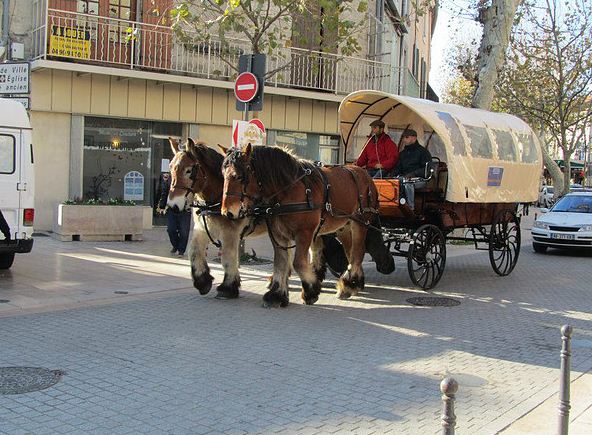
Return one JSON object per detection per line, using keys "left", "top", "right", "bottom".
{"left": 356, "top": 119, "right": 399, "bottom": 178}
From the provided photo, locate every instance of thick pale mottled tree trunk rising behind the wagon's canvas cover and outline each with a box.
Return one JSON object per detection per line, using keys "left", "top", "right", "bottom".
{"left": 471, "top": 0, "right": 522, "bottom": 110}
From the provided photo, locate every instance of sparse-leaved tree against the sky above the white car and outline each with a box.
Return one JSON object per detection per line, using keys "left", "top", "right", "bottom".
{"left": 499, "top": 0, "right": 592, "bottom": 194}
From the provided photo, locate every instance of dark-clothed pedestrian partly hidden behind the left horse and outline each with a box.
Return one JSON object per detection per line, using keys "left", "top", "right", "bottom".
{"left": 156, "top": 172, "right": 191, "bottom": 257}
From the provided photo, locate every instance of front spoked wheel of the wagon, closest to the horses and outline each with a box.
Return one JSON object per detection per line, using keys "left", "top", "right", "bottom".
{"left": 407, "top": 224, "right": 446, "bottom": 290}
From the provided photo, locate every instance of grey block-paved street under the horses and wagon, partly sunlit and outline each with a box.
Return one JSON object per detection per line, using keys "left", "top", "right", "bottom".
{"left": 0, "top": 210, "right": 592, "bottom": 434}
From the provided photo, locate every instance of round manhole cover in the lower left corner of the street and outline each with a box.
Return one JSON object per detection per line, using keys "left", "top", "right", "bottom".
{"left": 0, "top": 367, "right": 64, "bottom": 394}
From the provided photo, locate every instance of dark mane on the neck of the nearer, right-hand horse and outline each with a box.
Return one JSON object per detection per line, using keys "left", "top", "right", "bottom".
{"left": 251, "top": 146, "right": 320, "bottom": 190}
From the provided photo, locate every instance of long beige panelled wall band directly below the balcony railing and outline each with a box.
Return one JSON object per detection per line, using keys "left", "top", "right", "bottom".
{"left": 31, "top": 69, "right": 338, "bottom": 134}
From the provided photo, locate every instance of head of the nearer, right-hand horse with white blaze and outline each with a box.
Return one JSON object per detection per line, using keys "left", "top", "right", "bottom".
{"left": 220, "top": 144, "right": 258, "bottom": 219}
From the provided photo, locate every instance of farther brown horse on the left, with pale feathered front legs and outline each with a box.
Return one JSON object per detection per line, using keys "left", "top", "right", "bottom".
{"left": 167, "top": 138, "right": 265, "bottom": 299}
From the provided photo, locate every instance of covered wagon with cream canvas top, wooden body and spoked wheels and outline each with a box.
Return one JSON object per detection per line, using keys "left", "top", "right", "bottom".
{"left": 339, "top": 91, "right": 542, "bottom": 289}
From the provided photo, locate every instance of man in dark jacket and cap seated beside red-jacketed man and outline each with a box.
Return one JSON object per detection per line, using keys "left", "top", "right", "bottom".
{"left": 393, "top": 129, "right": 432, "bottom": 210}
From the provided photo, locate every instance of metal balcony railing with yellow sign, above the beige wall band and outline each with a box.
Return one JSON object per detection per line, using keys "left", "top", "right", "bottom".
{"left": 33, "top": 0, "right": 403, "bottom": 94}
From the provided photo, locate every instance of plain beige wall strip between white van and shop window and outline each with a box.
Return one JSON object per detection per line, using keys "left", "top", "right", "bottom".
{"left": 30, "top": 110, "right": 71, "bottom": 230}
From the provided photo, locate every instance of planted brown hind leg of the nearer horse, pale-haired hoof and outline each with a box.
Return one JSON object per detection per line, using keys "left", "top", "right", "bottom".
{"left": 337, "top": 223, "right": 367, "bottom": 299}
